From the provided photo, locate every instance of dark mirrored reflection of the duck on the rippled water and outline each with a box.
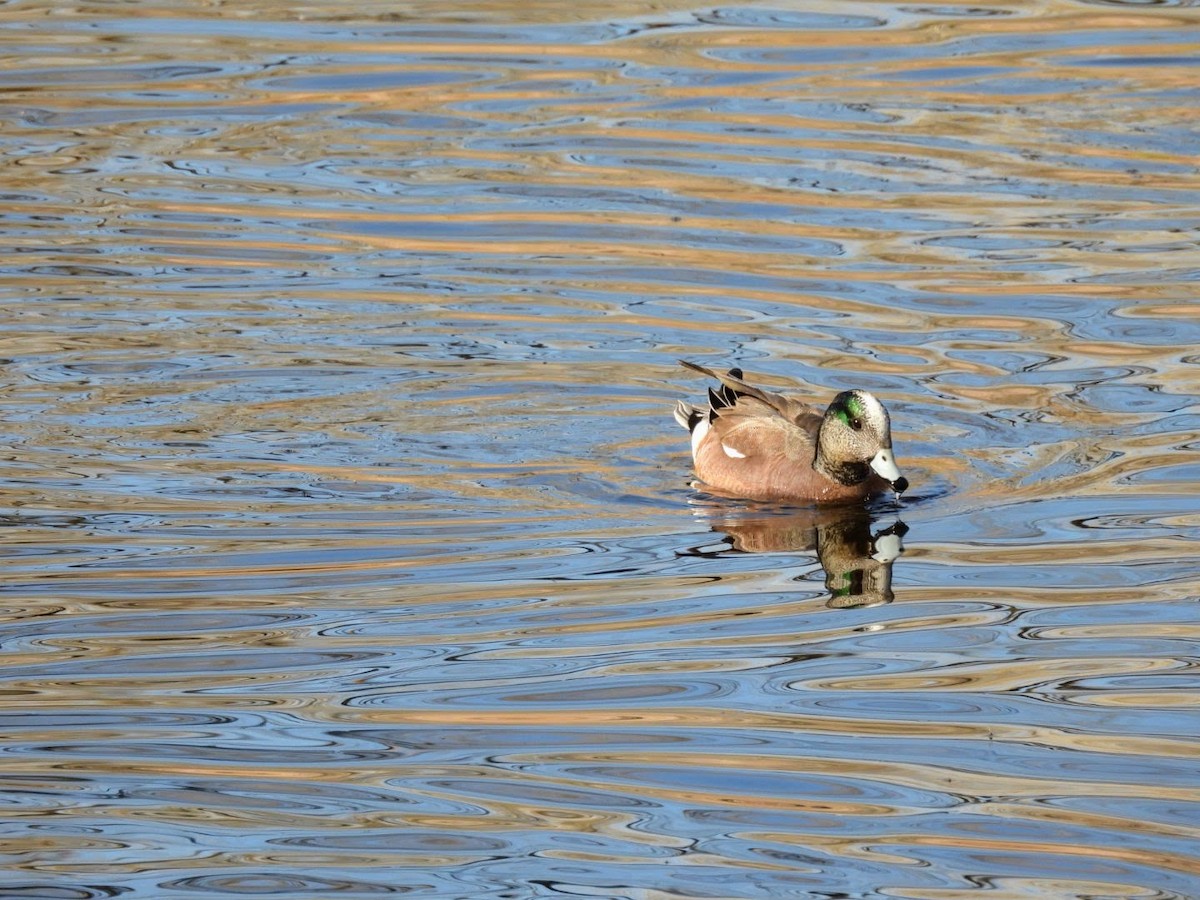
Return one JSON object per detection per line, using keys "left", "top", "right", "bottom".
{"left": 706, "top": 508, "right": 908, "bottom": 608}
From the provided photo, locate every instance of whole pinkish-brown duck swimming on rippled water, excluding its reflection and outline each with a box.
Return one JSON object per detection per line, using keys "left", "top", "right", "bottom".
{"left": 674, "top": 360, "right": 908, "bottom": 505}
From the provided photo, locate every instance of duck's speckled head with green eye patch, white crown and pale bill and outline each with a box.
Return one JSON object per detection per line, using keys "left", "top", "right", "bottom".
{"left": 815, "top": 390, "right": 908, "bottom": 493}
